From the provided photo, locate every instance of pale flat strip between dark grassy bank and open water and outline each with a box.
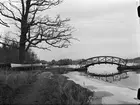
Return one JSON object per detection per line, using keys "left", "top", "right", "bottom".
{"left": 64, "top": 72, "right": 140, "bottom": 104}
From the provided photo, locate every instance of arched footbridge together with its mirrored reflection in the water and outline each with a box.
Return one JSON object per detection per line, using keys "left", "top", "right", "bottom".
{"left": 77, "top": 56, "right": 140, "bottom": 82}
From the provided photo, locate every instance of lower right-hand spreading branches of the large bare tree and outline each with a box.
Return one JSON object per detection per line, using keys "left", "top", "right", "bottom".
{"left": 27, "top": 17, "right": 75, "bottom": 48}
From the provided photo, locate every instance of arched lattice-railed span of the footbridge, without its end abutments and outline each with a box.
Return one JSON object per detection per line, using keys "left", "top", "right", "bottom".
{"left": 80, "top": 56, "right": 127, "bottom": 68}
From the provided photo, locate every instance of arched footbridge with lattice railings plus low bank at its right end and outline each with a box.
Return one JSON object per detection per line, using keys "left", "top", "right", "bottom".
{"left": 79, "top": 56, "right": 140, "bottom": 71}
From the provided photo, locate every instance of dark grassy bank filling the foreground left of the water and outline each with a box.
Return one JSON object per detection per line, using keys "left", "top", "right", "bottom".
{"left": 0, "top": 69, "right": 93, "bottom": 105}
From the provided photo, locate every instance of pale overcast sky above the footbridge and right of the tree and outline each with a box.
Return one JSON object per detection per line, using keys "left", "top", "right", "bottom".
{"left": 0, "top": 0, "right": 140, "bottom": 61}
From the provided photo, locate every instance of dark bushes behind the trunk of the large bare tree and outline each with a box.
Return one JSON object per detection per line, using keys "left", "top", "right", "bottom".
{"left": 0, "top": 37, "right": 40, "bottom": 63}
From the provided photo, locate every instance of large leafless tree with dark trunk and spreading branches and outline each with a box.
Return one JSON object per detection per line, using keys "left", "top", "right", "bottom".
{"left": 0, "top": 0, "right": 74, "bottom": 63}
